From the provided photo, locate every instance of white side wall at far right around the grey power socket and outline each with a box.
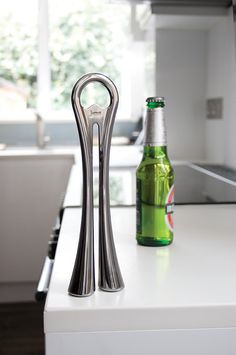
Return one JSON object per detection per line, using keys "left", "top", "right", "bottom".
{"left": 206, "top": 9, "right": 236, "bottom": 168}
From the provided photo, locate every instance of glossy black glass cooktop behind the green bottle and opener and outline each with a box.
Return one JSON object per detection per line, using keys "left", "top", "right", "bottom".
{"left": 63, "top": 163, "right": 236, "bottom": 208}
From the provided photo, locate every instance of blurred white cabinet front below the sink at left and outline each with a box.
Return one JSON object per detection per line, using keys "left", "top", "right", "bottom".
{"left": 0, "top": 149, "right": 74, "bottom": 286}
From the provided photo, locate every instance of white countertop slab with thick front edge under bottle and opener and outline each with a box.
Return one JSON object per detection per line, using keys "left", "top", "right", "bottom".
{"left": 44, "top": 205, "right": 236, "bottom": 333}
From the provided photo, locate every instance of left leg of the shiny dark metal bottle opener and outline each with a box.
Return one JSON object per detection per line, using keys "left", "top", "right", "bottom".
{"left": 68, "top": 78, "right": 95, "bottom": 297}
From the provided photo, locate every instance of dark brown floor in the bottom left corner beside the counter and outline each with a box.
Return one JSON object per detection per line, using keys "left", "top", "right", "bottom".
{"left": 0, "top": 302, "right": 45, "bottom": 355}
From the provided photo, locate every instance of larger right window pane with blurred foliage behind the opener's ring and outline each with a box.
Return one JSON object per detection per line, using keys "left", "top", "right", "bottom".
{"left": 49, "top": 0, "right": 130, "bottom": 115}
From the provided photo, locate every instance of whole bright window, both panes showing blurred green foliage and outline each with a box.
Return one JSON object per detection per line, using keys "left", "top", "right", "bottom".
{"left": 0, "top": 0, "right": 136, "bottom": 117}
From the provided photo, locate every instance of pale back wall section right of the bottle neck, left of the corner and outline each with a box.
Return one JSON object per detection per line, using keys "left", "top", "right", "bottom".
{"left": 156, "top": 29, "right": 207, "bottom": 160}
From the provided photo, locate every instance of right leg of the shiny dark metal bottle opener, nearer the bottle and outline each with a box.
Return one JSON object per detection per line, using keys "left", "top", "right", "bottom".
{"left": 98, "top": 81, "right": 124, "bottom": 292}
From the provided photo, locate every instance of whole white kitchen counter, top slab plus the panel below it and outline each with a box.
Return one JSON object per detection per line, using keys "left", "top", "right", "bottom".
{"left": 44, "top": 204, "right": 236, "bottom": 355}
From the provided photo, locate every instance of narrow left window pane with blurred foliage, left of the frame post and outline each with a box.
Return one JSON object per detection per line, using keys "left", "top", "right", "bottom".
{"left": 0, "top": 0, "right": 38, "bottom": 118}
